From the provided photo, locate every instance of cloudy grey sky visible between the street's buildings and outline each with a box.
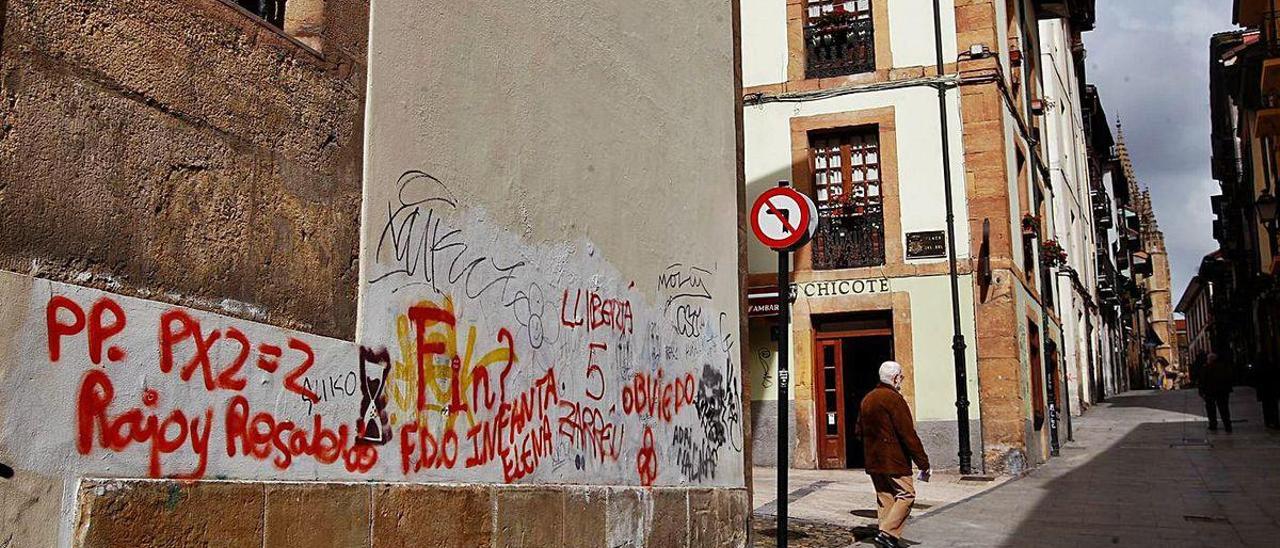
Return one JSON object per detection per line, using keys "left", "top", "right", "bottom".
{"left": 1084, "top": 0, "right": 1234, "bottom": 303}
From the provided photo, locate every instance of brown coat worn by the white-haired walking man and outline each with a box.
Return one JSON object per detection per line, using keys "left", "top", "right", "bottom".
{"left": 856, "top": 383, "right": 929, "bottom": 476}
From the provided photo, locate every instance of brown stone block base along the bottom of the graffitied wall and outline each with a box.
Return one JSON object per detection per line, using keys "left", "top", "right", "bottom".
{"left": 74, "top": 479, "right": 750, "bottom": 548}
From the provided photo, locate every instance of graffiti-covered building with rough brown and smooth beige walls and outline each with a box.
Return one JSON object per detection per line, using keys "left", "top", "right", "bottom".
{"left": 0, "top": 0, "right": 750, "bottom": 547}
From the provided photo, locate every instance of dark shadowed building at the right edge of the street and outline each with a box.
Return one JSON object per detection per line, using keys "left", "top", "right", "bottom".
{"left": 1201, "top": 0, "right": 1280, "bottom": 428}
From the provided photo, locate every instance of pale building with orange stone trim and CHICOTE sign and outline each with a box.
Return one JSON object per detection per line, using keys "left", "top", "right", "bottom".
{"left": 742, "top": 0, "right": 1093, "bottom": 472}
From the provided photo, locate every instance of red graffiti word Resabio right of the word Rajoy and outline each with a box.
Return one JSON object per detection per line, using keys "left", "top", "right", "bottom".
{"left": 227, "top": 394, "right": 378, "bottom": 474}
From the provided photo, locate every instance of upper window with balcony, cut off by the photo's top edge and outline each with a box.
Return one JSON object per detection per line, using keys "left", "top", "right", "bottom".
{"left": 804, "top": 0, "right": 876, "bottom": 78}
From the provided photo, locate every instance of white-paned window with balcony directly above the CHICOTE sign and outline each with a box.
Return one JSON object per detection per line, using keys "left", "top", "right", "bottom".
{"left": 809, "top": 127, "right": 884, "bottom": 270}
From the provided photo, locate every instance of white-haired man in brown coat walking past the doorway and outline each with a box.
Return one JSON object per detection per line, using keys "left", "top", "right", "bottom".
{"left": 856, "top": 361, "right": 929, "bottom": 547}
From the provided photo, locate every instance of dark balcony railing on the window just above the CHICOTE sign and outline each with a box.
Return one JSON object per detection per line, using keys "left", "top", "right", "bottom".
{"left": 813, "top": 210, "right": 884, "bottom": 270}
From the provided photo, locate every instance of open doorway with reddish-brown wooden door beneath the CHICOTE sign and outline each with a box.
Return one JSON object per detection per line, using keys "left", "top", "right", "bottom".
{"left": 814, "top": 311, "right": 893, "bottom": 469}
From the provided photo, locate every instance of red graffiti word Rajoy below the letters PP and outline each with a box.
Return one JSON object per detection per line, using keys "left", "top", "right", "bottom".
{"left": 76, "top": 369, "right": 214, "bottom": 479}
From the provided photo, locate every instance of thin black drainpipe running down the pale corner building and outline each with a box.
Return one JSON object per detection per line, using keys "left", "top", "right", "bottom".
{"left": 933, "top": 0, "right": 973, "bottom": 474}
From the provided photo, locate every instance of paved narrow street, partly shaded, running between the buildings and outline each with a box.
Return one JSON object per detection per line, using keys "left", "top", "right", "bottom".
{"left": 755, "top": 388, "right": 1280, "bottom": 548}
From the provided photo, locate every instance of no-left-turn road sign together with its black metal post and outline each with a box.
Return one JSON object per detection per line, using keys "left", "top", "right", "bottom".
{"left": 751, "top": 181, "right": 818, "bottom": 548}
